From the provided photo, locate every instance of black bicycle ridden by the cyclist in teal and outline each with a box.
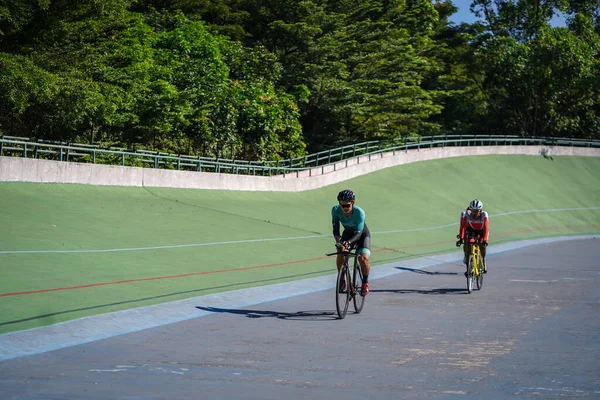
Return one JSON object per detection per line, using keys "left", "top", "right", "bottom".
{"left": 326, "top": 247, "right": 365, "bottom": 319}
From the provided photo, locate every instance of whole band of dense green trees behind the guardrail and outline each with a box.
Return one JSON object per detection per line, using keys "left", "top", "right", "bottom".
{"left": 0, "top": 0, "right": 600, "bottom": 160}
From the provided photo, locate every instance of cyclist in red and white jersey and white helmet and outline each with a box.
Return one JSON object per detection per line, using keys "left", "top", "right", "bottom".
{"left": 456, "top": 199, "right": 490, "bottom": 273}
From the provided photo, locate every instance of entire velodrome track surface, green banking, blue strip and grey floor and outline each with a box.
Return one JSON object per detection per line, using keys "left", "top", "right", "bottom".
{"left": 0, "top": 152, "right": 600, "bottom": 399}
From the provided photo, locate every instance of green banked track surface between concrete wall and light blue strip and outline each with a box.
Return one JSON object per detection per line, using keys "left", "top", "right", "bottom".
{"left": 0, "top": 156, "right": 600, "bottom": 333}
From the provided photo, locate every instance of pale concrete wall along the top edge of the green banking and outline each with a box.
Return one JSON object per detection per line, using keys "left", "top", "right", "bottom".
{"left": 0, "top": 146, "right": 600, "bottom": 192}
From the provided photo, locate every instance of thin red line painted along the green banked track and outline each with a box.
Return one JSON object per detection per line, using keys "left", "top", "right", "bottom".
{"left": 0, "top": 225, "right": 600, "bottom": 297}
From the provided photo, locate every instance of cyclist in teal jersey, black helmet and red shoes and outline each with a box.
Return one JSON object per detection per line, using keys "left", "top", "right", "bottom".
{"left": 331, "top": 189, "right": 371, "bottom": 296}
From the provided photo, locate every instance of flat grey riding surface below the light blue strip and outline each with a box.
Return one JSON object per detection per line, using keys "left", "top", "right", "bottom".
{"left": 0, "top": 239, "right": 600, "bottom": 400}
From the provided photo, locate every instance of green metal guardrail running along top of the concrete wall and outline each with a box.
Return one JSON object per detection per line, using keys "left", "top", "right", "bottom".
{"left": 0, "top": 135, "right": 600, "bottom": 176}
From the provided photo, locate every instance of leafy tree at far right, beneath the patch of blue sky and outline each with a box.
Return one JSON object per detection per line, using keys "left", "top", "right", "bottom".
{"left": 473, "top": 0, "right": 600, "bottom": 137}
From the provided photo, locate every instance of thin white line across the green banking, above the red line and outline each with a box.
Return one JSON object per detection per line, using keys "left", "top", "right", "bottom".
{"left": 0, "top": 207, "right": 600, "bottom": 254}
